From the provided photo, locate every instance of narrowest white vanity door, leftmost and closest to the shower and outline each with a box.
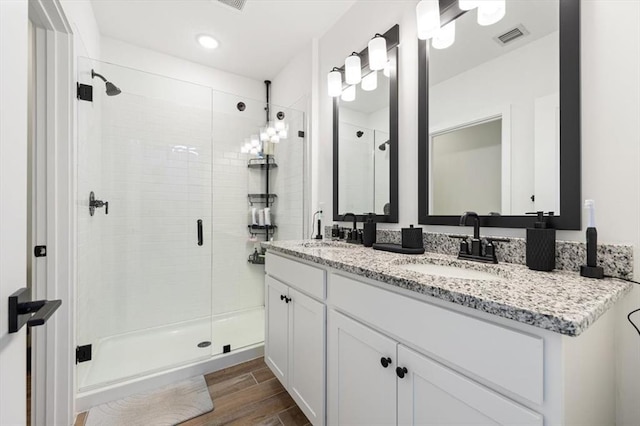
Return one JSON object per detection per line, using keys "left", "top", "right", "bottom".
{"left": 264, "top": 275, "right": 289, "bottom": 387}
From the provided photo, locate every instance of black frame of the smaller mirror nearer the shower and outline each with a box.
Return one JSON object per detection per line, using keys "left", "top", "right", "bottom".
{"left": 333, "top": 24, "right": 400, "bottom": 223}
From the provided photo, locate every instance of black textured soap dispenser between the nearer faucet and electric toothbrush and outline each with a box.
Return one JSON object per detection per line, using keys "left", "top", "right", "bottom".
{"left": 527, "top": 211, "right": 556, "bottom": 271}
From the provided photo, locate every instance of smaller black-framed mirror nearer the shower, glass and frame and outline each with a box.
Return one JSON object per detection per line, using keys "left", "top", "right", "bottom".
{"left": 333, "top": 25, "right": 399, "bottom": 223}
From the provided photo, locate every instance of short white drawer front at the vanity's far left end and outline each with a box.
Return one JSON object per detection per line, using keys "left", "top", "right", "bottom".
{"left": 265, "top": 251, "right": 326, "bottom": 300}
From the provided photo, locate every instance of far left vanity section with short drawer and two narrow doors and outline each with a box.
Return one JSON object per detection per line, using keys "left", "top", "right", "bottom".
{"left": 265, "top": 254, "right": 326, "bottom": 425}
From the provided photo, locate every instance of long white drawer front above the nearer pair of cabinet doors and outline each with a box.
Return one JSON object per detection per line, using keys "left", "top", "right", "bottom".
{"left": 328, "top": 274, "right": 544, "bottom": 404}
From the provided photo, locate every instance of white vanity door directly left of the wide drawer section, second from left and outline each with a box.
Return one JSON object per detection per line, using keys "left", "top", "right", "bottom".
{"left": 288, "top": 288, "right": 325, "bottom": 425}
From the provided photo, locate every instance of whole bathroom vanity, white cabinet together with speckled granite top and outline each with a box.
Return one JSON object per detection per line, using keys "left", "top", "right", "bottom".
{"left": 265, "top": 241, "right": 631, "bottom": 426}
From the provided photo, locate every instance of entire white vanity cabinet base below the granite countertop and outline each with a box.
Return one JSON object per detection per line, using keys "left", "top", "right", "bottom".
{"left": 265, "top": 252, "right": 615, "bottom": 426}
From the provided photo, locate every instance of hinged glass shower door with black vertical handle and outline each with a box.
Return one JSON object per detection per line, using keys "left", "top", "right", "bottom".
{"left": 77, "top": 59, "right": 213, "bottom": 391}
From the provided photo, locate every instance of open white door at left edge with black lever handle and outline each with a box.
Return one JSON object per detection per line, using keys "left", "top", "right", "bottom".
{"left": 0, "top": 0, "right": 28, "bottom": 426}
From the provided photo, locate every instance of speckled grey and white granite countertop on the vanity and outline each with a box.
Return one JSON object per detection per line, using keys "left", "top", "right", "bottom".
{"left": 263, "top": 240, "right": 632, "bottom": 336}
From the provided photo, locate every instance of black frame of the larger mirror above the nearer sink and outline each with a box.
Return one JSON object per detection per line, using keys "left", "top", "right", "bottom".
{"left": 418, "top": 0, "right": 582, "bottom": 230}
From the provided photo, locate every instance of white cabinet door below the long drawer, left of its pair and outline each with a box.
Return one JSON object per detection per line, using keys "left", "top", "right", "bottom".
{"left": 327, "top": 310, "right": 396, "bottom": 426}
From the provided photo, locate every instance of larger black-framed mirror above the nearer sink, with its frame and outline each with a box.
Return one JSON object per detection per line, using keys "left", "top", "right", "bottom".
{"left": 418, "top": 0, "right": 582, "bottom": 230}
